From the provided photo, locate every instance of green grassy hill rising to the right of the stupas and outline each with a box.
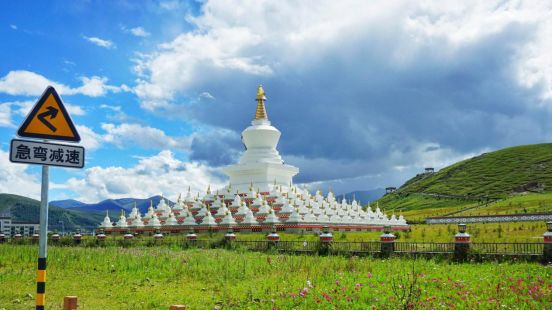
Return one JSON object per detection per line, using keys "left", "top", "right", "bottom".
{"left": 379, "top": 144, "right": 552, "bottom": 222}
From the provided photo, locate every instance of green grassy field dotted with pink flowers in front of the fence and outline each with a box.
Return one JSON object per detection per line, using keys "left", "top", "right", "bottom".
{"left": 0, "top": 245, "right": 552, "bottom": 309}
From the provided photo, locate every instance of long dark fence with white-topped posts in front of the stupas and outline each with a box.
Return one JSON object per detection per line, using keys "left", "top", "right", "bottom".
{"left": 0, "top": 222, "right": 552, "bottom": 264}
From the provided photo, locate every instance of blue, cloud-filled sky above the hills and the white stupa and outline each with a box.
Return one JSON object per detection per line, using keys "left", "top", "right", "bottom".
{"left": 0, "top": 0, "right": 552, "bottom": 202}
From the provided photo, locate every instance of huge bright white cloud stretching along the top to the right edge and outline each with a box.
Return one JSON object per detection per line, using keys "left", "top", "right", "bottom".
{"left": 135, "top": 0, "right": 552, "bottom": 109}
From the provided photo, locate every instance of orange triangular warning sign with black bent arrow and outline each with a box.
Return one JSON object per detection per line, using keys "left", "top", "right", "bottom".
{"left": 17, "top": 86, "right": 80, "bottom": 142}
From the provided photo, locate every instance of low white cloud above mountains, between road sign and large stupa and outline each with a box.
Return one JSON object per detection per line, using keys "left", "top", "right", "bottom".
{"left": 54, "top": 150, "right": 224, "bottom": 202}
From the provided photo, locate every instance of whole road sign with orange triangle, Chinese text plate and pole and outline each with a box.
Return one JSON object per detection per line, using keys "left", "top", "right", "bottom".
{"left": 10, "top": 86, "right": 84, "bottom": 310}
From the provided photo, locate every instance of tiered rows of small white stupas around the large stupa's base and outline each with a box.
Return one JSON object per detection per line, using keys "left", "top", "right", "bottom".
{"left": 100, "top": 186, "right": 408, "bottom": 232}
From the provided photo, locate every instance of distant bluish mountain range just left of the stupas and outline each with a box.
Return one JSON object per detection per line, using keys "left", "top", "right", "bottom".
{"left": 50, "top": 195, "right": 174, "bottom": 215}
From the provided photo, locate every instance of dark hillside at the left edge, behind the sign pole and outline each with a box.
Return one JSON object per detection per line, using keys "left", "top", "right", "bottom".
{"left": 0, "top": 193, "right": 103, "bottom": 231}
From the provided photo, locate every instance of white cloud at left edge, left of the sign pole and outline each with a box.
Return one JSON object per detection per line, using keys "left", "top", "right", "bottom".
{"left": 0, "top": 149, "right": 40, "bottom": 200}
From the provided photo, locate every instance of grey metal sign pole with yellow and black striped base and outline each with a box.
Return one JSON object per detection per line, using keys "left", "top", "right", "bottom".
{"left": 36, "top": 165, "right": 49, "bottom": 310}
